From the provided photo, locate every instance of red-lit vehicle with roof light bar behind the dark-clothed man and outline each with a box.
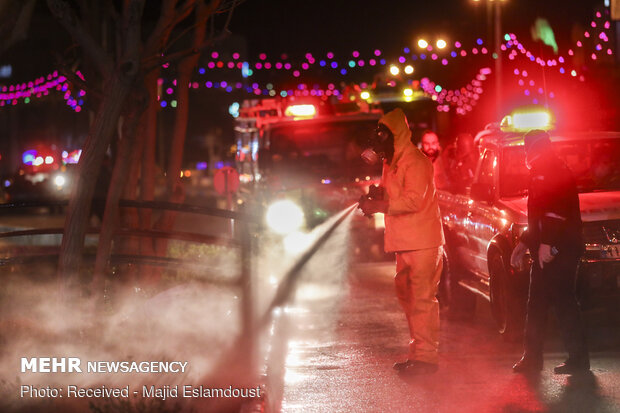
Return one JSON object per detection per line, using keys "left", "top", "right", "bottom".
{"left": 438, "top": 113, "right": 620, "bottom": 335}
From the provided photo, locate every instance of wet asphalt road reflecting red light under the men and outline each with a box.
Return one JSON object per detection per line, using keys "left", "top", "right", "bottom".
{"left": 270, "top": 265, "right": 620, "bottom": 413}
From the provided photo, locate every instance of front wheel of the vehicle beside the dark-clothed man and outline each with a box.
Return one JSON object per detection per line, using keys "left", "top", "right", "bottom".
{"left": 489, "top": 252, "right": 525, "bottom": 341}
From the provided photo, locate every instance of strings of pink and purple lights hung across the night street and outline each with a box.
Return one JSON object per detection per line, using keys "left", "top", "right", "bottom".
{"left": 0, "top": 8, "right": 614, "bottom": 112}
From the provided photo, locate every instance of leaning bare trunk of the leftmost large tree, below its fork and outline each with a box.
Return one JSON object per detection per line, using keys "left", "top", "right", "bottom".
{"left": 58, "top": 74, "right": 131, "bottom": 287}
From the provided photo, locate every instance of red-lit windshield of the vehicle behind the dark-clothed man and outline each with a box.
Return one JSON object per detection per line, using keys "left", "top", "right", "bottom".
{"left": 500, "top": 139, "right": 620, "bottom": 198}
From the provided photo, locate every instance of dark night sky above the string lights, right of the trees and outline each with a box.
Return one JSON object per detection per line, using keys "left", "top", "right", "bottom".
{"left": 230, "top": 0, "right": 601, "bottom": 55}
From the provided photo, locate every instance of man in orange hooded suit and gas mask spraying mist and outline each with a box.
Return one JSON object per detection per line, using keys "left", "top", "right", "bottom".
{"left": 360, "top": 109, "right": 444, "bottom": 374}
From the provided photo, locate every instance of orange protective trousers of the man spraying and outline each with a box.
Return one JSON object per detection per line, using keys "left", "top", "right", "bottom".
{"left": 394, "top": 247, "right": 443, "bottom": 363}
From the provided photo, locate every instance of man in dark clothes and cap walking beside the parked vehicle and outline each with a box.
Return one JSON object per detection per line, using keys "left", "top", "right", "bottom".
{"left": 510, "top": 130, "right": 590, "bottom": 374}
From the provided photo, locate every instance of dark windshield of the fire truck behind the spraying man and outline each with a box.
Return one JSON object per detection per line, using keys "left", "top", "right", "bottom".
{"left": 270, "top": 120, "right": 381, "bottom": 178}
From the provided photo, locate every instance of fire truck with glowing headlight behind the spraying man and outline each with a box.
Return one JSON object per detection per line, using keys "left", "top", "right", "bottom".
{"left": 235, "top": 97, "right": 384, "bottom": 260}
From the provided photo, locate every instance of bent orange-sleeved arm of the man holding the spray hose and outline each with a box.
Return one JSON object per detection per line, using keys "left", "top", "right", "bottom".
{"left": 387, "top": 162, "right": 433, "bottom": 215}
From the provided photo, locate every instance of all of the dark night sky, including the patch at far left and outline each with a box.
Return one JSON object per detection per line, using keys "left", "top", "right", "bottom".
{"left": 0, "top": 0, "right": 602, "bottom": 81}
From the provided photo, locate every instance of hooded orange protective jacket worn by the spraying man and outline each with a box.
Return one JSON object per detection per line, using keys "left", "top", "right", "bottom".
{"left": 379, "top": 108, "right": 444, "bottom": 252}
